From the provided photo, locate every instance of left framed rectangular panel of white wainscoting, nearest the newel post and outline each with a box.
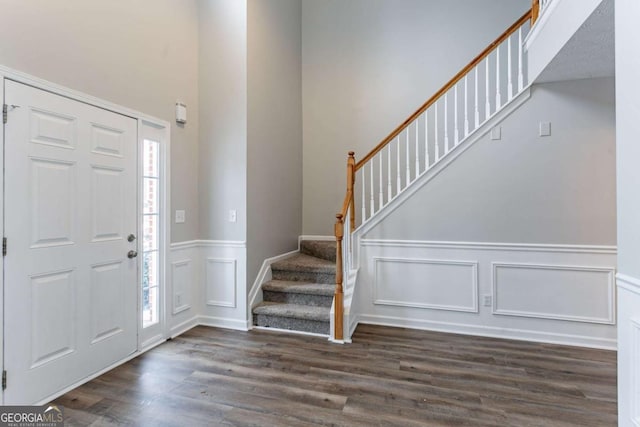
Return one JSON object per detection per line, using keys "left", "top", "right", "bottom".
{"left": 373, "top": 257, "right": 478, "bottom": 313}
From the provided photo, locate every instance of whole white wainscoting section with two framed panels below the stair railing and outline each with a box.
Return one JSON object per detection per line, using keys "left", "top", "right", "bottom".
{"left": 350, "top": 236, "right": 617, "bottom": 349}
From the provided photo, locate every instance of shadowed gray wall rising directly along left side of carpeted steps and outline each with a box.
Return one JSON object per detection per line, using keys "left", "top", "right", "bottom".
{"left": 247, "top": 0, "right": 302, "bottom": 285}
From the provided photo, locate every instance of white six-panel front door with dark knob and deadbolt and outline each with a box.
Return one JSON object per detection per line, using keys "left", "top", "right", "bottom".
{"left": 4, "top": 80, "right": 138, "bottom": 404}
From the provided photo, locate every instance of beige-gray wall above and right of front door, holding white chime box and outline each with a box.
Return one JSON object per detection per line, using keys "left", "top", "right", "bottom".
{"left": 0, "top": 0, "right": 199, "bottom": 241}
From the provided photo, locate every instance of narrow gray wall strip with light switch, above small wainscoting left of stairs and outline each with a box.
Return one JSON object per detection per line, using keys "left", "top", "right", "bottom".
{"left": 199, "top": 0, "right": 247, "bottom": 241}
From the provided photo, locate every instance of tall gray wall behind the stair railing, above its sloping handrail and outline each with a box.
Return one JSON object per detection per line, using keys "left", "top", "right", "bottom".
{"left": 302, "top": 0, "right": 531, "bottom": 235}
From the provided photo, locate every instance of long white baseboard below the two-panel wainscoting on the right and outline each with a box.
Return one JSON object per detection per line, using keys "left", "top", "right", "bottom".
{"left": 354, "top": 315, "right": 617, "bottom": 350}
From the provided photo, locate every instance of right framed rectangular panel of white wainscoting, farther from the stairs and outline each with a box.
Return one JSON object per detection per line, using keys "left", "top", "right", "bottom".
{"left": 493, "top": 263, "right": 615, "bottom": 325}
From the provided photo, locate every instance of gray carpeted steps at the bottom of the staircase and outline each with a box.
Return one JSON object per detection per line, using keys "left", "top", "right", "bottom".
{"left": 253, "top": 240, "right": 336, "bottom": 335}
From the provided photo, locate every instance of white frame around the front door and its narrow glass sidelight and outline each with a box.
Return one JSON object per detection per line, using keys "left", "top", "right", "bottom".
{"left": 0, "top": 65, "right": 171, "bottom": 403}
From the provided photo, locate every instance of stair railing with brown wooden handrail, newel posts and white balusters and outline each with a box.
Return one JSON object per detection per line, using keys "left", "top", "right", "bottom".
{"left": 334, "top": 6, "right": 536, "bottom": 340}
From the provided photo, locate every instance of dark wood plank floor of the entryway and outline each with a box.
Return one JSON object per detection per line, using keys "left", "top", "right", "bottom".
{"left": 56, "top": 325, "right": 617, "bottom": 427}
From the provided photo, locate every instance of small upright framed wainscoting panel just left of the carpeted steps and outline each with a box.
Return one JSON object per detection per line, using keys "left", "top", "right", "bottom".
{"left": 204, "top": 258, "right": 238, "bottom": 308}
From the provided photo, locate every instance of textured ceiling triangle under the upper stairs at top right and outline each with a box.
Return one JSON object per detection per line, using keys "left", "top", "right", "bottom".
{"left": 536, "top": 0, "right": 615, "bottom": 83}
